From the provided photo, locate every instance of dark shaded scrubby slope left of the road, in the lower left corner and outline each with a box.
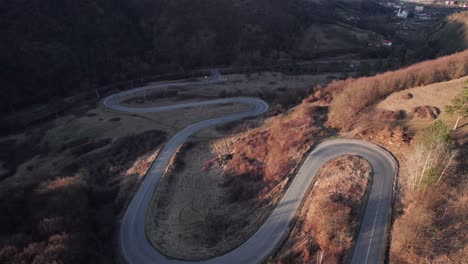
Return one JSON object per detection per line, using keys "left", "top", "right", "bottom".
{"left": 0, "top": 99, "right": 252, "bottom": 263}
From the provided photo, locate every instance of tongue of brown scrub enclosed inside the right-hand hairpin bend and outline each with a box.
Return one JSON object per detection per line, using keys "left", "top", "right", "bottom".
{"left": 270, "top": 155, "right": 371, "bottom": 264}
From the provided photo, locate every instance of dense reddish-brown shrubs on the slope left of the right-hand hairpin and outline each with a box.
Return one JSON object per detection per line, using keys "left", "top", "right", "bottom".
{"left": 224, "top": 101, "right": 329, "bottom": 202}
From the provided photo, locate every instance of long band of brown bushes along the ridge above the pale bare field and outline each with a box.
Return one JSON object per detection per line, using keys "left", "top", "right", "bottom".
{"left": 325, "top": 50, "right": 468, "bottom": 128}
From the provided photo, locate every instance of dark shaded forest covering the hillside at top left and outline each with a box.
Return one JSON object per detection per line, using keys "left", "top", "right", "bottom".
{"left": 0, "top": 0, "right": 388, "bottom": 113}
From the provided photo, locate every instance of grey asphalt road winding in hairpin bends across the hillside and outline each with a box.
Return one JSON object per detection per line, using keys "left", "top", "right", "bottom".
{"left": 108, "top": 72, "right": 397, "bottom": 264}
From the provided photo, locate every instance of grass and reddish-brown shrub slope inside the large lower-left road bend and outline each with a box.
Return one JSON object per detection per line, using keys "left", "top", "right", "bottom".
{"left": 148, "top": 94, "right": 332, "bottom": 260}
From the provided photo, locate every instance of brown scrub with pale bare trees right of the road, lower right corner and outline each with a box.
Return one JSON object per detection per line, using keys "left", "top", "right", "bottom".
{"left": 390, "top": 121, "right": 468, "bottom": 263}
